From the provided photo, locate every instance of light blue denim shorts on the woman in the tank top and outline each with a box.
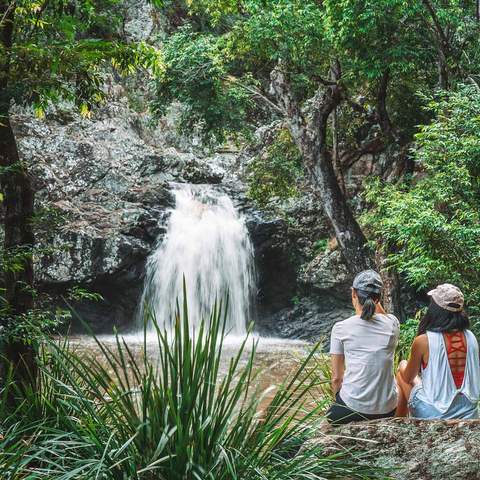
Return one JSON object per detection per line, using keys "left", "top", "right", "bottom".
{"left": 408, "top": 384, "right": 478, "bottom": 419}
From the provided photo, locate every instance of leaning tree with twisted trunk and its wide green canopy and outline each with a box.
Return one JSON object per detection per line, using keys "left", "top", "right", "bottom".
{"left": 155, "top": 0, "right": 480, "bottom": 280}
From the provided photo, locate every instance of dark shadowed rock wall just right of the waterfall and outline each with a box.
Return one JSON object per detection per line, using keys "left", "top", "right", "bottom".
{"left": 244, "top": 186, "right": 352, "bottom": 341}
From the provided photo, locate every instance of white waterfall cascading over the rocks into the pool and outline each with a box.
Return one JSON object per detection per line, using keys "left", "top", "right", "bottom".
{"left": 139, "top": 185, "right": 255, "bottom": 335}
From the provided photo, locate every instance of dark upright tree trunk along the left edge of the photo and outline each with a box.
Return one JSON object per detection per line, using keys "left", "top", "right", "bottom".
{"left": 0, "top": 1, "right": 36, "bottom": 387}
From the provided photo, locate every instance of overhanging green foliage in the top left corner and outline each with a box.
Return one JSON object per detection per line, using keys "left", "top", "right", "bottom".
{"left": 0, "top": 0, "right": 162, "bottom": 116}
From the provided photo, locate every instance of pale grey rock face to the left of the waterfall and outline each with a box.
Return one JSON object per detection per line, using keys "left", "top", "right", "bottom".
{"left": 14, "top": 97, "right": 248, "bottom": 330}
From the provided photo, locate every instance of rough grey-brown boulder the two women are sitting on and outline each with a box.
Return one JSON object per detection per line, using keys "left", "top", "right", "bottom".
{"left": 311, "top": 418, "right": 480, "bottom": 480}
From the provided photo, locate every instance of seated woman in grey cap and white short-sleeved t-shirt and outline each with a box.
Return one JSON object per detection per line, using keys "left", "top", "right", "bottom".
{"left": 327, "top": 270, "right": 400, "bottom": 424}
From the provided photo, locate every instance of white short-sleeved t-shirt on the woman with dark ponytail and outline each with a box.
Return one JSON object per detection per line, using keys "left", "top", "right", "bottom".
{"left": 330, "top": 313, "right": 400, "bottom": 414}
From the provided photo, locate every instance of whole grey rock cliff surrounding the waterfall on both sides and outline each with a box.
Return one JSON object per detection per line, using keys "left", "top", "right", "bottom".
{"left": 7, "top": 0, "right": 349, "bottom": 339}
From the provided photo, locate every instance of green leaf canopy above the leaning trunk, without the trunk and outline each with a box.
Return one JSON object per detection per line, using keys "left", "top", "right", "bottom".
{"left": 157, "top": 0, "right": 478, "bottom": 148}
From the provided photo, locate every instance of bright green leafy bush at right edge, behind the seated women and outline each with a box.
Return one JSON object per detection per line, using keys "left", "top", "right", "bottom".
{"left": 364, "top": 85, "right": 480, "bottom": 315}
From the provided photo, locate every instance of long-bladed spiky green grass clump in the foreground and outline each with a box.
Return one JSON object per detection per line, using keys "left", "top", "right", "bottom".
{"left": 0, "top": 294, "right": 384, "bottom": 480}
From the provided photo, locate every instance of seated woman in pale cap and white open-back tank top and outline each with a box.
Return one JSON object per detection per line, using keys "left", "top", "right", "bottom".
{"left": 397, "top": 283, "right": 480, "bottom": 419}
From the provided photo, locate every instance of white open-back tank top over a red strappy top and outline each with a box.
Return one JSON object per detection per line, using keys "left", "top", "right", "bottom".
{"left": 419, "top": 330, "right": 480, "bottom": 413}
